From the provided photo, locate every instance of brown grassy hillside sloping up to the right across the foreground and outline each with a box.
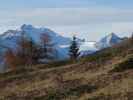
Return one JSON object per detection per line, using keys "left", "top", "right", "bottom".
{"left": 0, "top": 39, "right": 133, "bottom": 100}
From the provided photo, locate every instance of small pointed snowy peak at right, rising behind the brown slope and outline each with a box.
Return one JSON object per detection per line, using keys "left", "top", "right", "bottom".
{"left": 95, "top": 33, "right": 122, "bottom": 49}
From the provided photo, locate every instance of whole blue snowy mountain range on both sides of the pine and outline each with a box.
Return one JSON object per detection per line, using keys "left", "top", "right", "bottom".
{"left": 0, "top": 24, "right": 122, "bottom": 71}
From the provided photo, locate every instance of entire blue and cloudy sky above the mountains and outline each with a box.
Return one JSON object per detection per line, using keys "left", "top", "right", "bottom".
{"left": 0, "top": 0, "right": 133, "bottom": 41}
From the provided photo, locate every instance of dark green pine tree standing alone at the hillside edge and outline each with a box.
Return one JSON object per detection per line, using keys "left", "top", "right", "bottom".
{"left": 69, "top": 36, "right": 80, "bottom": 60}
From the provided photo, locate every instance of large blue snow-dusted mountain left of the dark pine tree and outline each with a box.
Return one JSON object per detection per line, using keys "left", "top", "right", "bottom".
{"left": 0, "top": 24, "right": 71, "bottom": 59}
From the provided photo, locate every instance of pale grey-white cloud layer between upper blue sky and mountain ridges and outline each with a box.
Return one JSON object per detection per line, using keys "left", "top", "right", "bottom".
{"left": 0, "top": 7, "right": 133, "bottom": 39}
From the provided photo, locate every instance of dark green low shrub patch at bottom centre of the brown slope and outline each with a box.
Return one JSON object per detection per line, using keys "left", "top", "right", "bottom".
{"left": 36, "top": 85, "right": 97, "bottom": 100}
